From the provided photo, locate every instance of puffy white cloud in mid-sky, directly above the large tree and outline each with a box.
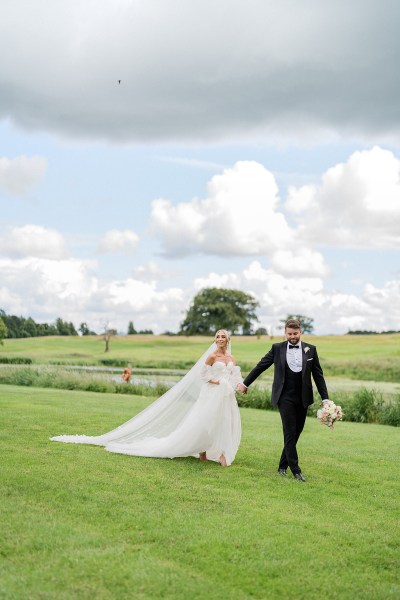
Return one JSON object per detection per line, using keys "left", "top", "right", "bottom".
{"left": 150, "top": 161, "right": 291, "bottom": 256}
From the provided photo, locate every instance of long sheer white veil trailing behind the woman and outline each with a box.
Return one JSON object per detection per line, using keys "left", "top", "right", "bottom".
{"left": 50, "top": 342, "right": 219, "bottom": 446}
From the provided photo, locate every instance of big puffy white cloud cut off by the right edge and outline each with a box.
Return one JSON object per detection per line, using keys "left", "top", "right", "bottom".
{"left": 286, "top": 146, "right": 400, "bottom": 248}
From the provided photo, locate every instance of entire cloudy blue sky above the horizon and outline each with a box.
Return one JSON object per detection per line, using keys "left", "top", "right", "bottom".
{"left": 0, "top": 0, "right": 400, "bottom": 335}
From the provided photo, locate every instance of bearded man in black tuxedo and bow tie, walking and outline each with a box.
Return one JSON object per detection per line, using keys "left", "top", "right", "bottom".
{"left": 238, "top": 319, "right": 328, "bottom": 481}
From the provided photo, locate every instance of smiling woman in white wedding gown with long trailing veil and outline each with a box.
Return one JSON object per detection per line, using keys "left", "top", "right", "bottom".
{"left": 50, "top": 329, "right": 243, "bottom": 467}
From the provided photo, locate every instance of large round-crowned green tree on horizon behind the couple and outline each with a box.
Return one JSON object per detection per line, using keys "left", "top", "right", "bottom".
{"left": 179, "top": 288, "right": 259, "bottom": 335}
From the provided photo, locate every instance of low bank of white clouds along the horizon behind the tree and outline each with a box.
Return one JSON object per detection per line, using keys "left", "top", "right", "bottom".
{"left": 0, "top": 247, "right": 400, "bottom": 333}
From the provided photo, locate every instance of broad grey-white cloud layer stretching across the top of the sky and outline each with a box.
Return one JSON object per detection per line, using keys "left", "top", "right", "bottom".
{"left": 0, "top": 0, "right": 400, "bottom": 142}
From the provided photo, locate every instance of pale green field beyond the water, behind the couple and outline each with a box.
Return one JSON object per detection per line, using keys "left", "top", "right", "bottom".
{"left": 0, "top": 334, "right": 400, "bottom": 383}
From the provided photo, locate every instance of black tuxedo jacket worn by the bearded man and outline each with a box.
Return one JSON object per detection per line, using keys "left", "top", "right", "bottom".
{"left": 243, "top": 342, "right": 329, "bottom": 406}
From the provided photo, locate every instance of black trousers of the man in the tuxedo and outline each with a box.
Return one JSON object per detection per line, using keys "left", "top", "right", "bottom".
{"left": 278, "top": 396, "right": 307, "bottom": 474}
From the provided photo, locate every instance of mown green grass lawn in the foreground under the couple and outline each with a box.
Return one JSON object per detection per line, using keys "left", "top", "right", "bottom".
{"left": 0, "top": 386, "right": 400, "bottom": 600}
